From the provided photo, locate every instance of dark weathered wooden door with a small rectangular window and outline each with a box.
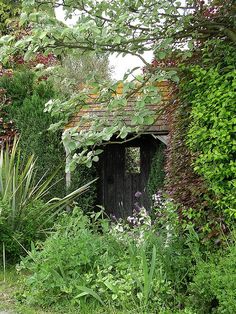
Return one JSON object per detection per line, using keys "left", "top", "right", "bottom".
{"left": 98, "top": 136, "right": 158, "bottom": 218}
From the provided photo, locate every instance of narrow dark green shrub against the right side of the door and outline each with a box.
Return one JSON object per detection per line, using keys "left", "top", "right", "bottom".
{"left": 147, "top": 143, "right": 165, "bottom": 197}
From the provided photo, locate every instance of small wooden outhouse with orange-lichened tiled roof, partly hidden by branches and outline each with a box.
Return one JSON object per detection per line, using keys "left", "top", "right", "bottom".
{"left": 68, "top": 81, "right": 172, "bottom": 217}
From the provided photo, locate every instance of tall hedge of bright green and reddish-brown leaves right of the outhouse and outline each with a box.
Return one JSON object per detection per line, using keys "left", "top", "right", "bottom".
{"left": 165, "top": 41, "right": 236, "bottom": 240}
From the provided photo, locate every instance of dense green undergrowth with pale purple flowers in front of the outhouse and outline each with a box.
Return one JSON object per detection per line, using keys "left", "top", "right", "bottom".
{"left": 13, "top": 201, "right": 236, "bottom": 314}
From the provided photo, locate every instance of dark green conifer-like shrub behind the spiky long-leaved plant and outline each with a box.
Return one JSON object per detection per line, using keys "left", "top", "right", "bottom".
{"left": 0, "top": 68, "right": 65, "bottom": 196}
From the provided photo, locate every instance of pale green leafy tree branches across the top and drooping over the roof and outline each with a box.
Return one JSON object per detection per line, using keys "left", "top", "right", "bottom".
{"left": 1, "top": 0, "right": 236, "bottom": 170}
